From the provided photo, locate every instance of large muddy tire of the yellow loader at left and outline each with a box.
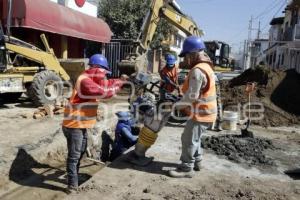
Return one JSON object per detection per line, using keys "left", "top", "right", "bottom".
{"left": 28, "top": 70, "right": 63, "bottom": 106}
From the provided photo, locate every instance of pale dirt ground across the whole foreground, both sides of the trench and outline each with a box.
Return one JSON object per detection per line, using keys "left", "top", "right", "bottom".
{"left": 0, "top": 97, "right": 300, "bottom": 200}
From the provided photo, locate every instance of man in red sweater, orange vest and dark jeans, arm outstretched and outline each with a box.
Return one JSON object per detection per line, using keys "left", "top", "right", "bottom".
{"left": 62, "top": 54, "right": 127, "bottom": 191}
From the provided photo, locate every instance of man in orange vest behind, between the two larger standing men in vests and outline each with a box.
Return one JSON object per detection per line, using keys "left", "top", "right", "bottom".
{"left": 159, "top": 54, "right": 179, "bottom": 101}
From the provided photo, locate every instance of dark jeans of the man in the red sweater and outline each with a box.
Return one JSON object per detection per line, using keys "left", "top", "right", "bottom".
{"left": 62, "top": 127, "right": 87, "bottom": 187}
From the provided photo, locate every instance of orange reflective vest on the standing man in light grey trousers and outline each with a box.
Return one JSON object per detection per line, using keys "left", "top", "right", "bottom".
{"left": 182, "top": 63, "right": 217, "bottom": 123}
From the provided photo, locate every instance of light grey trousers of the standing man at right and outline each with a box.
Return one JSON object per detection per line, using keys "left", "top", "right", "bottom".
{"left": 180, "top": 119, "right": 211, "bottom": 171}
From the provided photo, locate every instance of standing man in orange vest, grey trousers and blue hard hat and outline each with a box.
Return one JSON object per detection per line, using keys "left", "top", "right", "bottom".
{"left": 169, "top": 36, "right": 217, "bottom": 178}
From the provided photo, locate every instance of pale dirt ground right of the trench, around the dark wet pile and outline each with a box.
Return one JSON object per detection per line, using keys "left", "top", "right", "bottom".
{"left": 67, "top": 124, "right": 300, "bottom": 200}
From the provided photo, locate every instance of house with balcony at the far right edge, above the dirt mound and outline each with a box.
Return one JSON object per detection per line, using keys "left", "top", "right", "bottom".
{"left": 265, "top": 0, "right": 300, "bottom": 73}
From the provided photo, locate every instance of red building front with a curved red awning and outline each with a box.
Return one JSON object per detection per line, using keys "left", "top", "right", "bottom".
{"left": 0, "top": 0, "right": 112, "bottom": 59}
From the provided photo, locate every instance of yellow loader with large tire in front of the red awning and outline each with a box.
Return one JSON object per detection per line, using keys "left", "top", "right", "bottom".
{"left": 0, "top": 30, "right": 70, "bottom": 105}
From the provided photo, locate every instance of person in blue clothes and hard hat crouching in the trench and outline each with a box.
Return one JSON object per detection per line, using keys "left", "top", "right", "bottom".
{"left": 110, "top": 111, "right": 139, "bottom": 160}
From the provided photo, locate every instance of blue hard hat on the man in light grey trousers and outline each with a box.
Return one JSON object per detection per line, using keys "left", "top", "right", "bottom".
{"left": 179, "top": 35, "right": 205, "bottom": 57}
